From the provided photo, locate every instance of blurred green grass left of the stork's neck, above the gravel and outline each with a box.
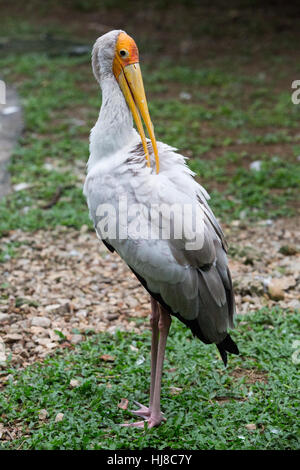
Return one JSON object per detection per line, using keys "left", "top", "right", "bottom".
{"left": 0, "top": 54, "right": 96, "bottom": 233}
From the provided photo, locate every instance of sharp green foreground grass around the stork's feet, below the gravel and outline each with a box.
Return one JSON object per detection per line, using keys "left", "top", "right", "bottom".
{"left": 0, "top": 309, "right": 300, "bottom": 449}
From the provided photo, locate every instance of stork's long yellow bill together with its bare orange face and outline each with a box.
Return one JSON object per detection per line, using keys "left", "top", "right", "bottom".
{"left": 114, "top": 33, "right": 159, "bottom": 173}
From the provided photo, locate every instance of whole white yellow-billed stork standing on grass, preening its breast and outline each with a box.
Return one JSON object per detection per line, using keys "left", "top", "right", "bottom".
{"left": 84, "top": 30, "right": 239, "bottom": 428}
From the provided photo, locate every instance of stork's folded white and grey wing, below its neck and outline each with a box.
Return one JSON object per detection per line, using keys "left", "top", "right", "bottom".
{"left": 84, "top": 145, "right": 234, "bottom": 343}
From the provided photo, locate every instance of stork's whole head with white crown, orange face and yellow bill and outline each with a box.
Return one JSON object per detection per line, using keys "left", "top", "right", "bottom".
{"left": 92, "top": 30, "right": 159, "bottom": 173}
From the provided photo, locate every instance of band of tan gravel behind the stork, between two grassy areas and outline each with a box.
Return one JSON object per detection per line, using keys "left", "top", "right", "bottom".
{"left": 0, "top": 219, "right": 300, "bottom": 374}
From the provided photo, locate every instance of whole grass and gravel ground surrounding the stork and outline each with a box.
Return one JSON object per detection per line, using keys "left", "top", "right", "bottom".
{"left": 0, "top": 0, "right": 300, "bottom": 449}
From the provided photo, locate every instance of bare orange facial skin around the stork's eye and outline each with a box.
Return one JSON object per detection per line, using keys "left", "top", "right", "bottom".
{"left": 113, "top": 33, "right": 139, "bottom": 79}
